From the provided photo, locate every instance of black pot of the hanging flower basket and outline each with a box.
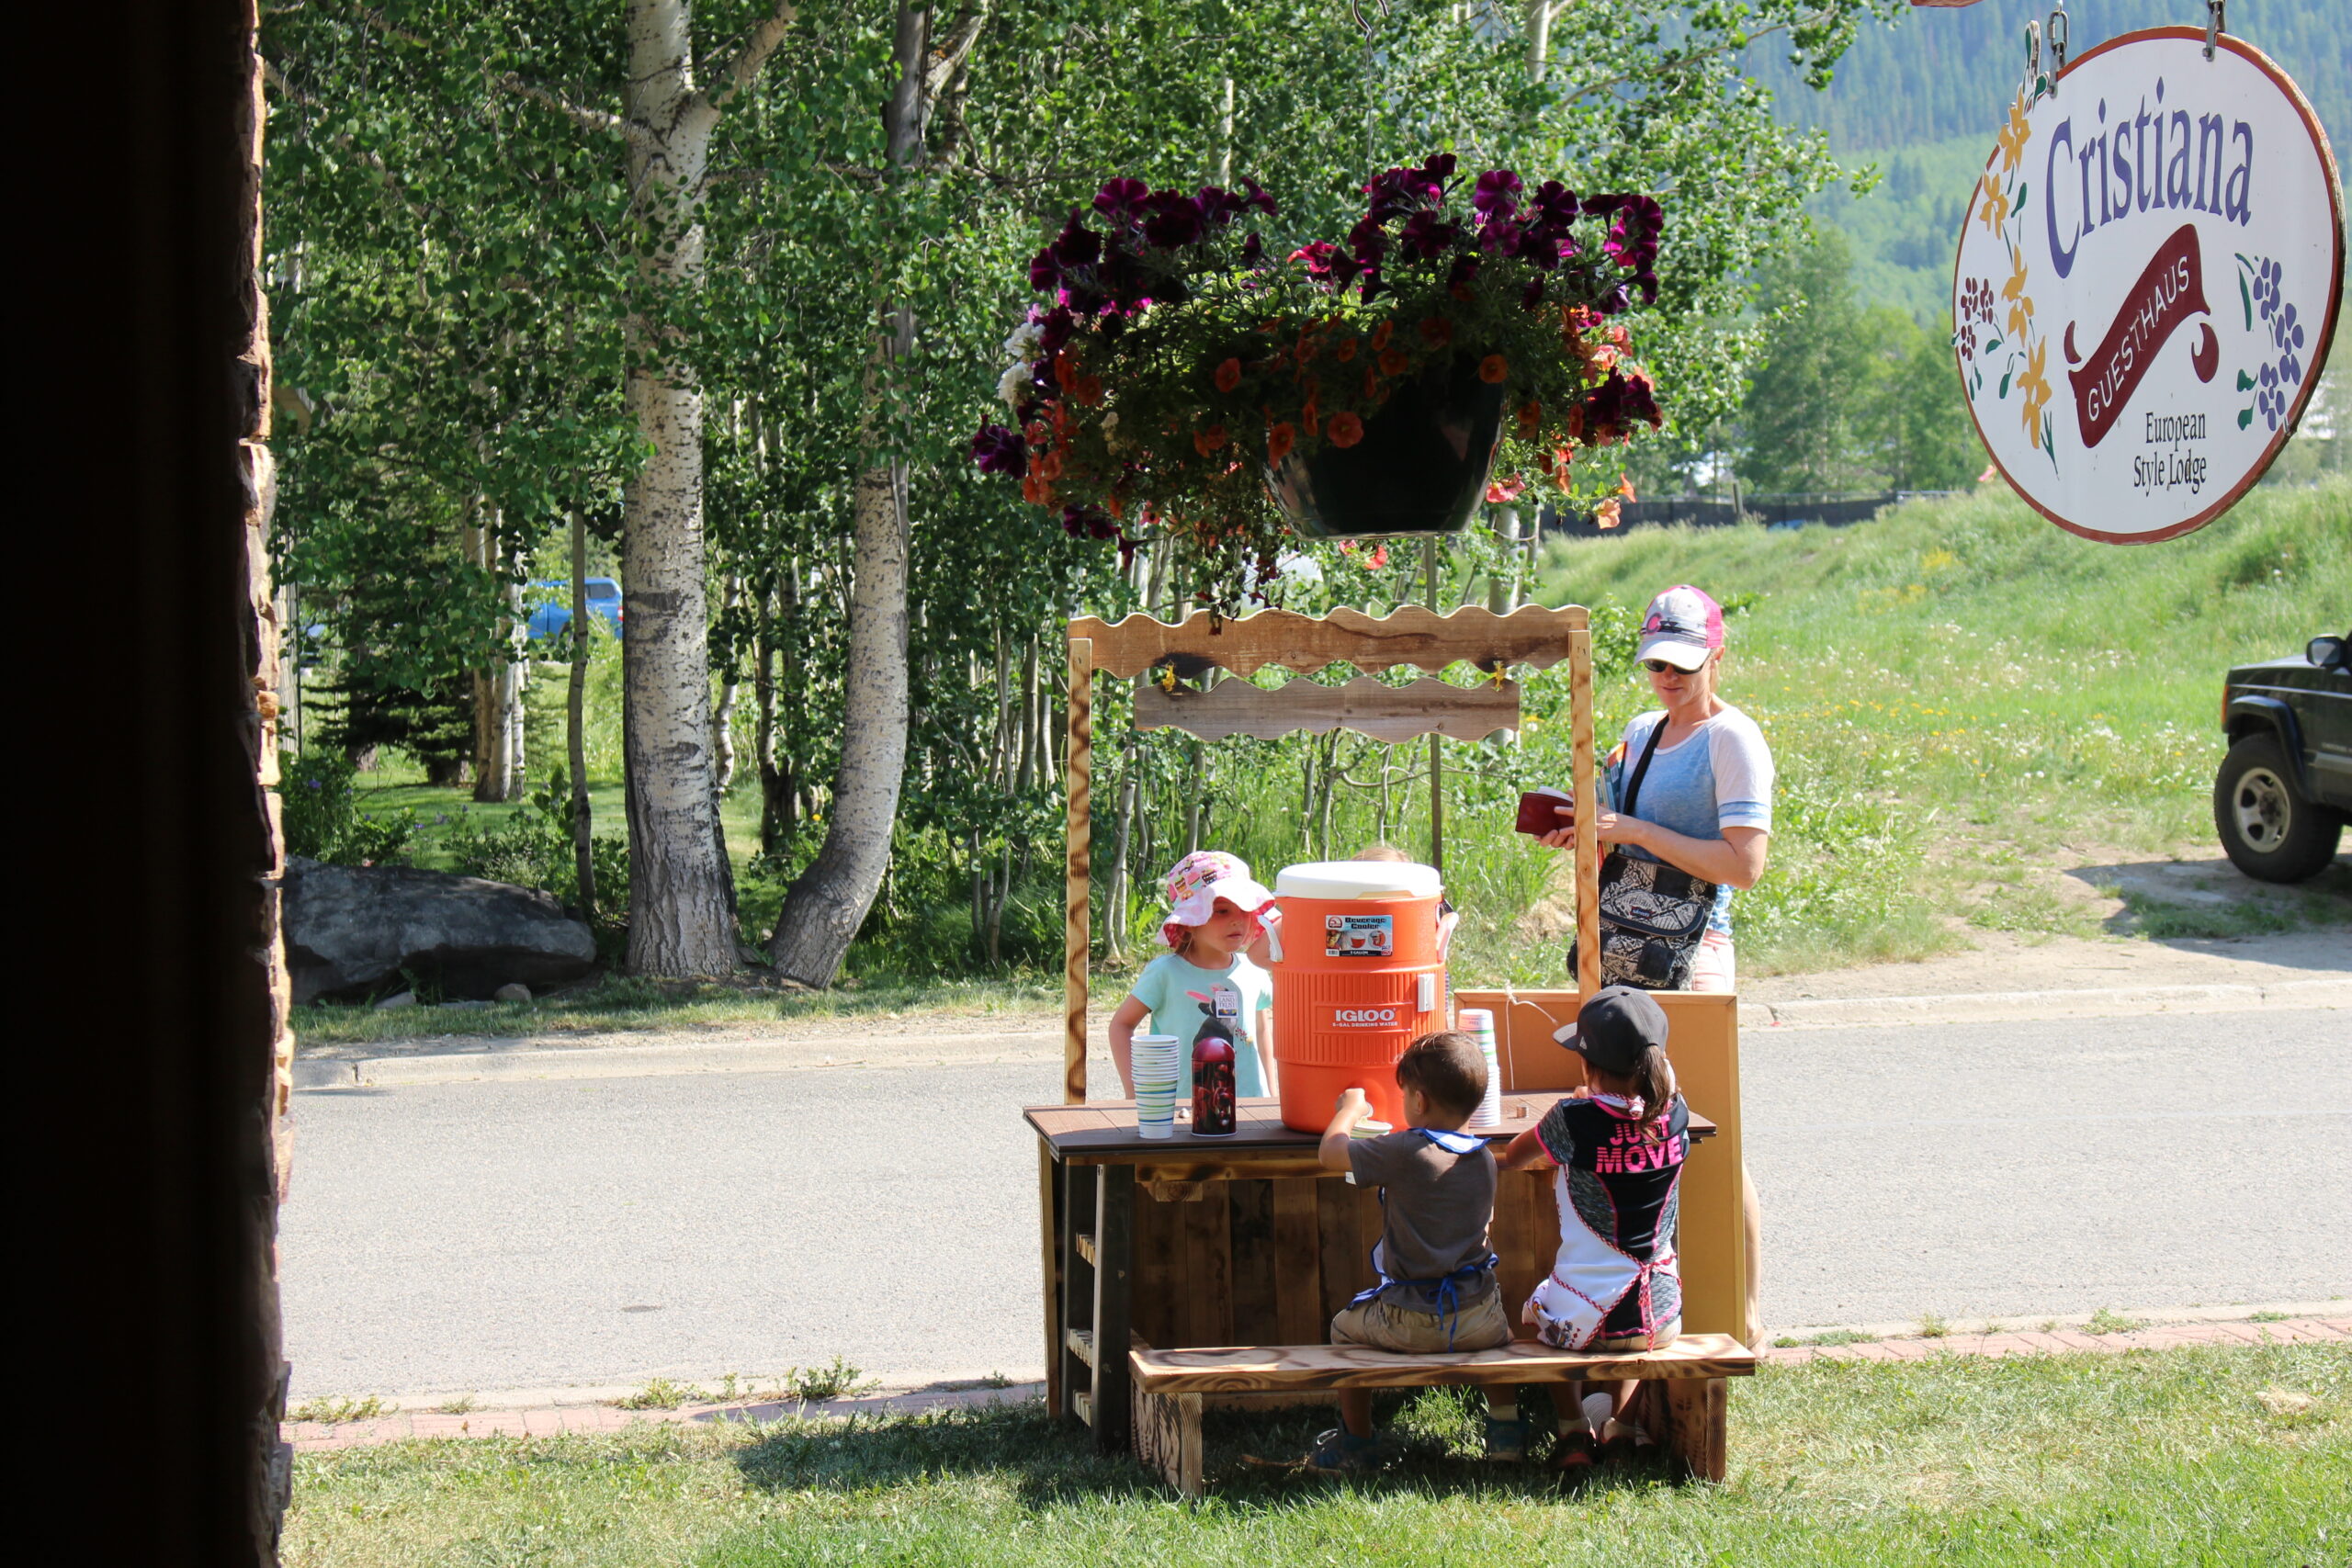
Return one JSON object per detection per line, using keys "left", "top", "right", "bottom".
{"left": 1265, "top": 355, "right": 1503, "bottom": 538}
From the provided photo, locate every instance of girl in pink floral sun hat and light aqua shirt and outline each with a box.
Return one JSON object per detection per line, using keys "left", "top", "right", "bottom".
{"left": 1110, "top": 849, "right": 1282, "bottom": 1105}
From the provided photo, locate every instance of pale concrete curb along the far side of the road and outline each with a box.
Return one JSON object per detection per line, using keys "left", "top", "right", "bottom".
{"left": 294, "top": 978, "right": 2352, "bottom": 1090}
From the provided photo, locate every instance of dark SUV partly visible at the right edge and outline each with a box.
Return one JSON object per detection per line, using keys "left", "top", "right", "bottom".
{"left": 2213, "top": 632, "right": 2352, "bottom": 882}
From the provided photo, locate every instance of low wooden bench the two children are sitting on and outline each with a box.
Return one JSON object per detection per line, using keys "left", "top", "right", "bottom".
{"left": 1126, "top": 1333, "right": 1757, "bottom": 1497}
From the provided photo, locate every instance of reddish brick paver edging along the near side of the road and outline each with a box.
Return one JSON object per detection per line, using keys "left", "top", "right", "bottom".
{"left": 285, "top": 1316, "right": 2352, "bottom": 1453}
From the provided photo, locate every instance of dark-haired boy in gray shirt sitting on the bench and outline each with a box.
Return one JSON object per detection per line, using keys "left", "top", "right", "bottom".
{"left": 1307, "top": 1030, "right": 1510, "bottom": 1470}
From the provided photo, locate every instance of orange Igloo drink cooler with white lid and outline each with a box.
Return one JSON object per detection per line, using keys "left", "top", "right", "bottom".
{"left": 1275, "top": 861, "right": 1446, "bottom": 1134}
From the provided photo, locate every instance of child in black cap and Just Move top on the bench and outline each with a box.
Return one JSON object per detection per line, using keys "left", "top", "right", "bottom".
{"left": 1500, "top": 985, "right": 1691, "bottom": 1470}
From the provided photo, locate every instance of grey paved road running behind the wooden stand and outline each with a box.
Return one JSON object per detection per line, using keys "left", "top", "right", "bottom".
{"left": 282, "top": 1009, "right": 2352, "bottom": 1399}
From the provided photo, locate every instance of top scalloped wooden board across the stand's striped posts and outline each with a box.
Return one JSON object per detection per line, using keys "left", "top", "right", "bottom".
{"left": 1070, "top": 604, "right": 1590, "bottom": 674}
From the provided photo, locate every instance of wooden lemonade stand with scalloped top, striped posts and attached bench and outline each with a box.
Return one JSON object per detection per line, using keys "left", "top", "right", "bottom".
{"left": 1025, "top": 604, "right": 1755, "bottom": 1495}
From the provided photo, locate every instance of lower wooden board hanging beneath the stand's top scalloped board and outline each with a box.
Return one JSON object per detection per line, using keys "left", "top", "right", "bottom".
{"left": 1136, "top": 674, "right": 1520, "bottom": 745}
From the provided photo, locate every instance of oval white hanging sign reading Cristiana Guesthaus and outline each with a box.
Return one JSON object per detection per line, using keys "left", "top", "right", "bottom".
{"left": 1952, "top": 28, "right": 2345, "bottom": 543}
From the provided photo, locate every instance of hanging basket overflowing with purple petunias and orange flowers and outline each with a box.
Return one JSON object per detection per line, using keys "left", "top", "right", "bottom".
{"left": 971, "top": 152, "right": 1665, "bottom": 606}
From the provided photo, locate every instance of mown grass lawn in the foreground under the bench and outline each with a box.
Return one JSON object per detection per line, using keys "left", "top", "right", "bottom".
{"left": 285, "top": 1345, "right": 2352, "bottom": 1568}
